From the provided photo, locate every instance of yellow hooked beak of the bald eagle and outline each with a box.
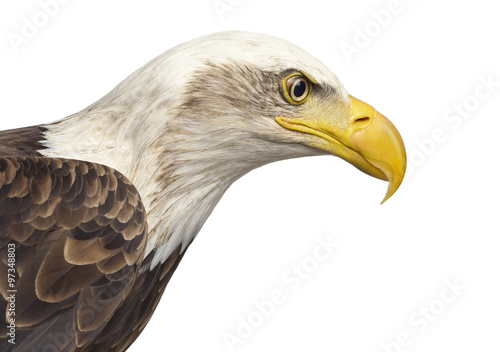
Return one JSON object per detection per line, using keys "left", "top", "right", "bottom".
{"left": 276, "top": 96, "right": 406, "bottom": 203}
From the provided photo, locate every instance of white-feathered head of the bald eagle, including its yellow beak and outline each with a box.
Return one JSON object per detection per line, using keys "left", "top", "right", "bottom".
{"left": 155, "top": 32, "right": 406, "bottom": 202}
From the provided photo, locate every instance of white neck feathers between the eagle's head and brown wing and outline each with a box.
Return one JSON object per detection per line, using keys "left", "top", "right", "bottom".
{"left": 40, "top": 106, "right": 254, "bottom": 266}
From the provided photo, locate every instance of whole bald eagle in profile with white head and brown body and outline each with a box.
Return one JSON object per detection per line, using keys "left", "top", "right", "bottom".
{"left": 0, "top": 32, "right": 406, "bottom": 352}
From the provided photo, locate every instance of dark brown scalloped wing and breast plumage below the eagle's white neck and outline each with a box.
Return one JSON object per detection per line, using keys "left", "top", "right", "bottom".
{"left": 0, "top": 157, "right": 166, "bottom": 352}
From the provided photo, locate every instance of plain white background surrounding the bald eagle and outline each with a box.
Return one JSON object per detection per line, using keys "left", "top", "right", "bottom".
{"left": 0, "top": 0, "right": 500, "bottom": 352}
